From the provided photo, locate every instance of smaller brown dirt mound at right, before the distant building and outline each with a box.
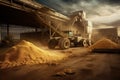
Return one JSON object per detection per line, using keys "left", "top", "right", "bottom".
{"left": 89, "top": 38, "right": 120, "bottom": 49}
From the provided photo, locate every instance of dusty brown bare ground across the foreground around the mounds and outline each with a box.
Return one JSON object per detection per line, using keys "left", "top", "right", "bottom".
{"left": 0, "top": 47, "right": 120, "bottom": 80}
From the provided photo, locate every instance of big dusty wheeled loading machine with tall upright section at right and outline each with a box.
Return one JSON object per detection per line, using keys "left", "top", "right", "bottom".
{"left": 48, "top": 11, "right": 92, "bottom": 49}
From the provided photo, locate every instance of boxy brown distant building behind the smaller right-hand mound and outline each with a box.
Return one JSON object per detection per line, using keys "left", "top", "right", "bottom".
{"left": 92, "top": 28, "right": 118, "bottom": 42}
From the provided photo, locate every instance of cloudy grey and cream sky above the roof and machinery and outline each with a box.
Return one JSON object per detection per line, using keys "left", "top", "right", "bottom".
{"left": 36, "top": 0, "right": 120, "bottom": 27}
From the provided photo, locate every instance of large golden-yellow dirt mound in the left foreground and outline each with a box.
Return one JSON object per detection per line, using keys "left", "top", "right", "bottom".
{"left": 0, "top": 40, "right": 66, "bottom": 68}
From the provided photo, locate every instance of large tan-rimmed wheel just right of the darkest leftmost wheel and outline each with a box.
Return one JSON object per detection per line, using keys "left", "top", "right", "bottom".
{"left": 59, "top": 38, "right": 70, "bottom": 49}
